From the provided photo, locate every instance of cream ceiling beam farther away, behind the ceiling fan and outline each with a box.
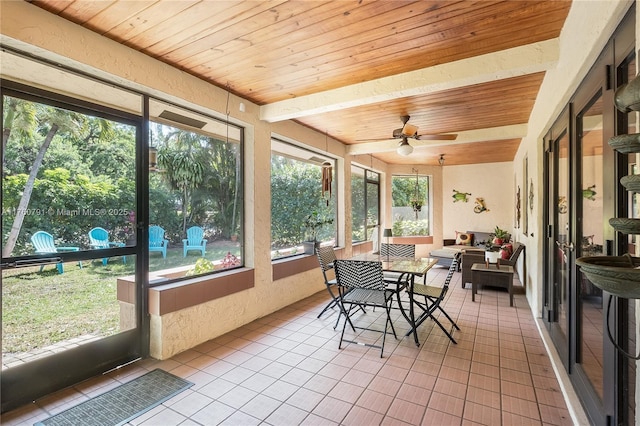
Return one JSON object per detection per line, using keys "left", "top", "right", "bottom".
{"left": 346, "top": 123, "right": 528, "bottom": 155}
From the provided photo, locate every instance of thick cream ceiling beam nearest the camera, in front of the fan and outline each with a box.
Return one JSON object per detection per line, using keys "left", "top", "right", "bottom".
{"left": 260, "top": 38, "right": 560, "bottom": 123}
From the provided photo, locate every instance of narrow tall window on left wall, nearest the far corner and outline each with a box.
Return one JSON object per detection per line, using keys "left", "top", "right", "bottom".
{"left": 351, "top": 166, "right": 380, "bottom": 242}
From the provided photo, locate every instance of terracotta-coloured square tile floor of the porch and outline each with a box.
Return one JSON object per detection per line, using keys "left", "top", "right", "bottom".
{"left": 1, "top": 268, "right": 572, "bottom": 426}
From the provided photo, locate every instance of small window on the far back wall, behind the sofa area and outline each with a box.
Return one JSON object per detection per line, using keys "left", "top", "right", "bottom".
{"left": 391, "top": 173, "right": 431, "bottom": 236}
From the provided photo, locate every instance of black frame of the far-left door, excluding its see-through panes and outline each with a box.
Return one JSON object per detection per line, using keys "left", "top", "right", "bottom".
{"left": 0, "top": 80, "right": 149, "bottom": 412}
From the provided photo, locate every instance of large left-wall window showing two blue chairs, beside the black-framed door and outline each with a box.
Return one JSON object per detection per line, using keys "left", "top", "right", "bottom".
{"left": 149, "top": 100, "right": 244, "bottom": 282}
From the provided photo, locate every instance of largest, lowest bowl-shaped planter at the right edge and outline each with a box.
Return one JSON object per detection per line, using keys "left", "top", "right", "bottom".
{"left": 576, "top": 255, "right": 640, "bottom": 299}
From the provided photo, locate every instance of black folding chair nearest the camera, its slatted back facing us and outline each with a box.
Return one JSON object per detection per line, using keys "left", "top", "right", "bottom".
{"left": 334, "top": 259, "right": 398, "bottom": 358}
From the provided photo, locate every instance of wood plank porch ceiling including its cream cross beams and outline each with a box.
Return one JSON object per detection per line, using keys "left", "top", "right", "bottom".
{"left": 32, "top": 0, "right": 571, "bottom": 165}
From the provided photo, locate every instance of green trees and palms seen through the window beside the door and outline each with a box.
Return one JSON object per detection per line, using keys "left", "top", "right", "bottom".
{"left": 150, "top": 123, "right": 242, "bottom": 241}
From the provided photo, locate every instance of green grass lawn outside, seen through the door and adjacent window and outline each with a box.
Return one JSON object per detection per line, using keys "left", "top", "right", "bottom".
{"left": 2, "top": 241, "right": 240, "bottom": 354}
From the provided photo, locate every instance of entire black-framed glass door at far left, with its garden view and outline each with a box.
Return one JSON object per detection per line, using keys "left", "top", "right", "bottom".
{"left": 1, "top": 88, "right": 141, "bottom": 411}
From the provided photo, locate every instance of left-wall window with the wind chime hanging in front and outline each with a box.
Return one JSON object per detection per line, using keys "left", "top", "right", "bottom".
{"left": 271, "top": 139, "right": 336, "bottom": 259}
